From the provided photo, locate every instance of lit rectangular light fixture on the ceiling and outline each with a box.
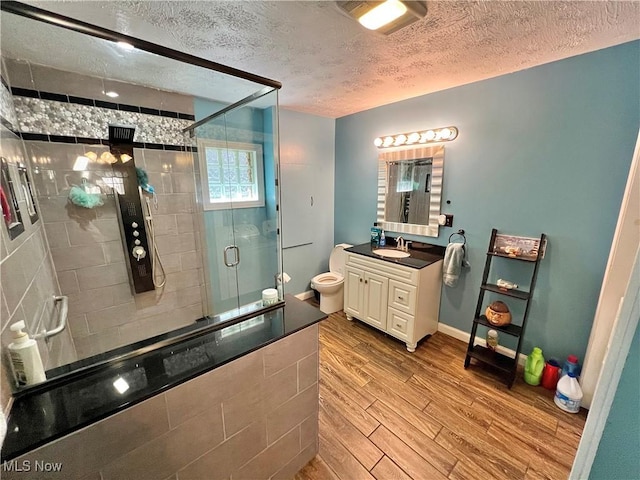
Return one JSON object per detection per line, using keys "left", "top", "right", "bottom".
{"left": 336, "top": 0, "right": 427, "bottom": 35}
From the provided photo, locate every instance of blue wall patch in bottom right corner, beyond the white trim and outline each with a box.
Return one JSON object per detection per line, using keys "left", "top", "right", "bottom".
{"left": 589, "top": 320, "right": 640, "bottom": 480}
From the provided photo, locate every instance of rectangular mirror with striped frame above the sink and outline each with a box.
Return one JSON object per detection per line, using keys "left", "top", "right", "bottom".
{"left": 377, "top": 145, "right": 444, "bottom": 237}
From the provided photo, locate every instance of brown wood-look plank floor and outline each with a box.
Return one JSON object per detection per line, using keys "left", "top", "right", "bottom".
{"left": 295, "top": 312, "right": 586, "bottom": 480}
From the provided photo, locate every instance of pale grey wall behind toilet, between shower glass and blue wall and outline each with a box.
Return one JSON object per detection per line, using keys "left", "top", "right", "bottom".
{"left": 279, "top": 109, "right": 335, "bottom": 295}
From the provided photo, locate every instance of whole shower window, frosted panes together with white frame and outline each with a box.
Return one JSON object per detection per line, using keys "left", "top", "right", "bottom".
{"left": 198, "top": 140, "right": 264, "bottom": 210}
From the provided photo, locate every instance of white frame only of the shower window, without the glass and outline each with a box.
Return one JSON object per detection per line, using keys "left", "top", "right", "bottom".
{"left": 198, "top": 139, "right": 265, "bottom": 210}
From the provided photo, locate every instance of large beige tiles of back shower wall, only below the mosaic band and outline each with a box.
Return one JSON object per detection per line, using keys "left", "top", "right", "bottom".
{"left": 25, "top": 141, "right": 203, "bottom": 358}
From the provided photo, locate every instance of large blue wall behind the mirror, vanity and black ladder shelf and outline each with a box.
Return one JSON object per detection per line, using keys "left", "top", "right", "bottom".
{"left": 335, "top": 42, "right": 640, "bottom": 358}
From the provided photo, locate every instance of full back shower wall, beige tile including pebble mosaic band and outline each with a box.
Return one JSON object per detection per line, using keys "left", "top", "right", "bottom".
{"left": 6, "top": 59, "right": 204, "bottom": 366}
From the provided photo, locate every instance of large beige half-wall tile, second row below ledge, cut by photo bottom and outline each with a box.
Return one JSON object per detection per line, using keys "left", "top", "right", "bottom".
{"left": 101, "top": 405, "right": 224, "bottom": 480}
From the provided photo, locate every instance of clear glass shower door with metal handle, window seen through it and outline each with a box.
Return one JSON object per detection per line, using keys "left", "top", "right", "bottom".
{"left": 195, "top": 92, "right": 282, "bottom": 317}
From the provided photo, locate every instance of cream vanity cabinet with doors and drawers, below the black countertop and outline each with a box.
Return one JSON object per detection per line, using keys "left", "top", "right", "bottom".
{"left": 344, "top": 252, "right": 442, "bottom": 352}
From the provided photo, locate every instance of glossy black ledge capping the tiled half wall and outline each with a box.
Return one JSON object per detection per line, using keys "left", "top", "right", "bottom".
{"left": 0, "top": 295, "right": 327, "bottom": 462}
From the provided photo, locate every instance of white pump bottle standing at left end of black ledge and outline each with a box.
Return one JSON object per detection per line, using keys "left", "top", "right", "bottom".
{"left": 8, "top": 320, "right": 47, "bottom": 386}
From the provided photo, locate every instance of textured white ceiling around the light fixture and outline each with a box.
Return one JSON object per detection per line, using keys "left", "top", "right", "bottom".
{"left": 10, "top": 1, "right": 640, "bottom": 117}
